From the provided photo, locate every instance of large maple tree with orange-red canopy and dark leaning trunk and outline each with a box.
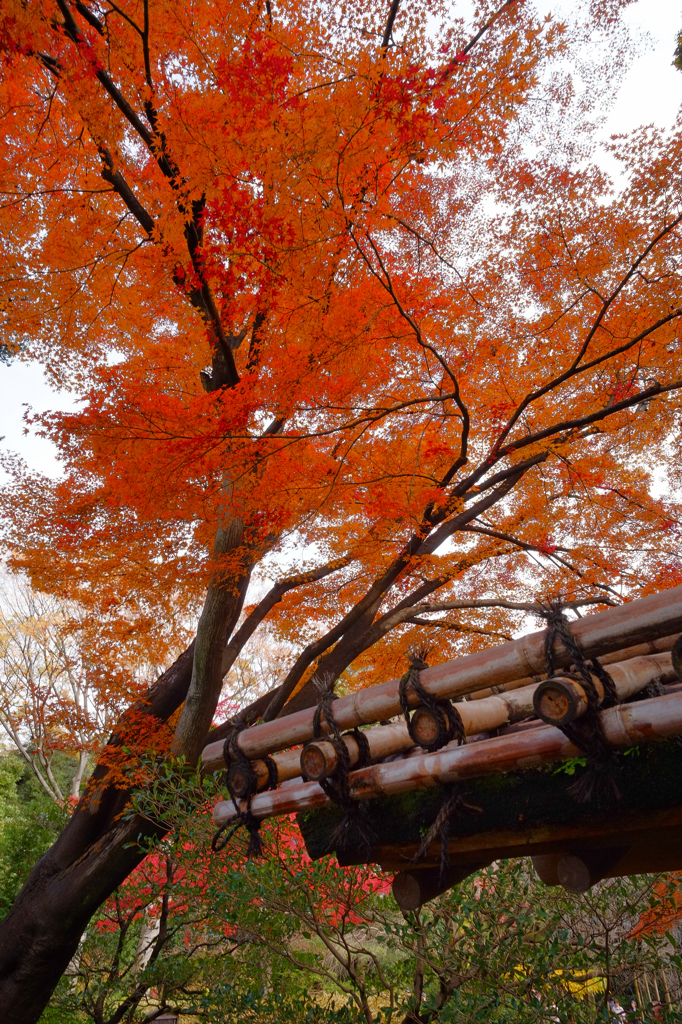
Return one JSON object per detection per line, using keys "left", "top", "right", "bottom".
{"left": 0, "top": 0, "right": 682, "bottom": 1021}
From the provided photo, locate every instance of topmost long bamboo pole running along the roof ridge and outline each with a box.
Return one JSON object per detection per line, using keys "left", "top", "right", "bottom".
{"left": 204, "top": 587, "right": 682, "bottom": 763}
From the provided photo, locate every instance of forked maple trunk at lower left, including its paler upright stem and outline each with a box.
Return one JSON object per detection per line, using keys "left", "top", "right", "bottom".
{"left": 0, "top": 501, "right": 260, "bottom": 1024}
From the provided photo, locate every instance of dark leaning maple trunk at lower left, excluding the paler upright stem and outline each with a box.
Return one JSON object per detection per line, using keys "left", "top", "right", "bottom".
{"left": 0, "top": 644, "right": 194, "bottom": 1024}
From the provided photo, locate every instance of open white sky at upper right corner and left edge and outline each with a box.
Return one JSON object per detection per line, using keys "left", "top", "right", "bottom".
{"left": 0, "top": 0, "right": 682, "bottom": 476}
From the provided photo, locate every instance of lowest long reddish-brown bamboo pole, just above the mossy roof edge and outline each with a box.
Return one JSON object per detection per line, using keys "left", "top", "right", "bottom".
{"left": 213, "top": 691, "right": 682, "bottom": 825}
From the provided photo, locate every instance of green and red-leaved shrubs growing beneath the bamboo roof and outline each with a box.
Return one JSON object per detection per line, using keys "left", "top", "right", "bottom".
{"left": 11, "top": 759, "right": 682, "bottom": 1024}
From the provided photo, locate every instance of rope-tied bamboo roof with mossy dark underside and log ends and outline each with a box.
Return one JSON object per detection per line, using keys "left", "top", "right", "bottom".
{"left": 204, "top": 588, "right": 682, "bottom": 908}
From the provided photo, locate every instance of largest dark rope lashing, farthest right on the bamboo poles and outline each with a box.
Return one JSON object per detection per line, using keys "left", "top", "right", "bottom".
{"left": 540, "top": 600, "right": 622, "bottom": 806}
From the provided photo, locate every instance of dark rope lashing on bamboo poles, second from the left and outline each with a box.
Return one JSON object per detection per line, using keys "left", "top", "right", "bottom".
{"left": 304, "top": 680, "right": 376, "bottom": 857}
